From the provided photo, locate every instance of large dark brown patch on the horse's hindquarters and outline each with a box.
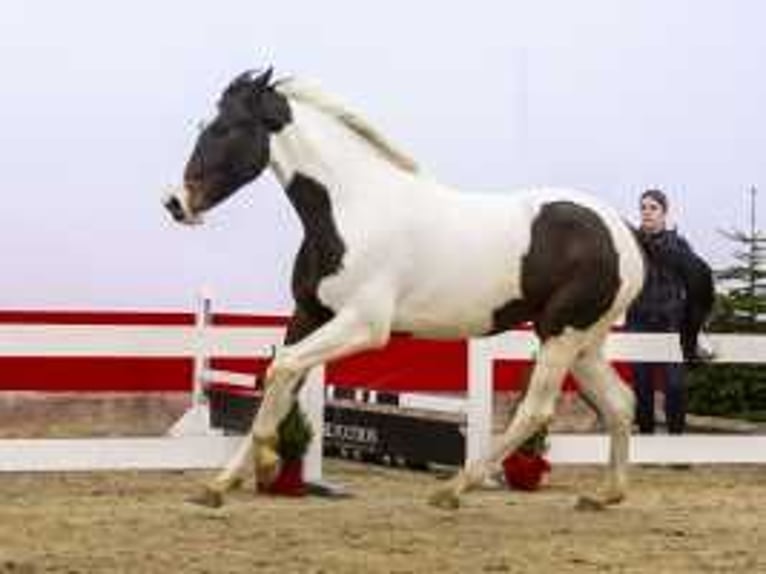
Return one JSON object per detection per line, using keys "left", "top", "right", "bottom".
{"left": 492, "top": 201, "right": 620, "bottom": 340}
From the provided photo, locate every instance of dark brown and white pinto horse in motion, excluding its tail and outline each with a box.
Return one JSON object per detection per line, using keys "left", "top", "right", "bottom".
{"left": 164, "top": 68, "right": 716, "bottom": 508}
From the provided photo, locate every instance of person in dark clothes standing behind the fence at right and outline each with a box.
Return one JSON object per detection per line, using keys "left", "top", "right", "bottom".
{"left": 626, "top": 189, "right": 696, "bottom": 434}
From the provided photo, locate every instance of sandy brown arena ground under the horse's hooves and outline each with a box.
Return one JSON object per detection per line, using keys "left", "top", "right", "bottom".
{"left": 0, "top": 460, "right": 766, "bottom": 574}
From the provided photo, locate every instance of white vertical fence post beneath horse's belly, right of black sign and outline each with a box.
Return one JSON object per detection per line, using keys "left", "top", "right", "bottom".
{"left": 465, "top": 339, "right": 493, "bottom": 463}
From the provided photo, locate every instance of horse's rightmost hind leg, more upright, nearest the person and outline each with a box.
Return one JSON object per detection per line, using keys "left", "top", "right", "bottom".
{"left": 572, "top": 345, "right": 635, "bottom": 509}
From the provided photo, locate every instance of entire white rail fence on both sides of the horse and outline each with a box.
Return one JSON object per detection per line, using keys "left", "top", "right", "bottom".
{"left": 0, "top": 321, "right": 766, "bottom": 472}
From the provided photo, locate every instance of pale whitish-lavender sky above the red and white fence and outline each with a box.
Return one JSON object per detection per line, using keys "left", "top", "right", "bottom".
{"left": 0, "top": 0, "right": 766, "bottom": 313}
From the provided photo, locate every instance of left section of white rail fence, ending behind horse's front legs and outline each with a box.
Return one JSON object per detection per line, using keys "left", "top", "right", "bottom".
{"left": 0, "top": 322, "right": 324, "bottom": 480}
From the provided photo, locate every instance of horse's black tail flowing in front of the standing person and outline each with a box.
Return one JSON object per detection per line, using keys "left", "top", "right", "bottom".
{"left": 633, "top": 229, "right": 715, "bottom": 365}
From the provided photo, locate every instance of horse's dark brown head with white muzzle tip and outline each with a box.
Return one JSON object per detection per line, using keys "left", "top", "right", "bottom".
{"left": 165, "top": 68, "right": 291, "bottom": 224}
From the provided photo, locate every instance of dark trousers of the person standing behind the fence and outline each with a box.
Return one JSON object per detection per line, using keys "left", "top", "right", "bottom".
{"left": 632, "top": 363, "right": 686, "bottom": 434}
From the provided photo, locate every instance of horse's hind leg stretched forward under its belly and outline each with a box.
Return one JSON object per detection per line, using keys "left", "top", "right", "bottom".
{"left": 430, "top": 333, "right": 581, "bottom": 508}
